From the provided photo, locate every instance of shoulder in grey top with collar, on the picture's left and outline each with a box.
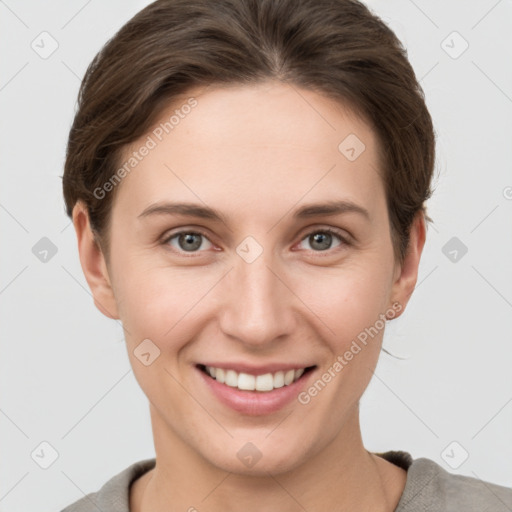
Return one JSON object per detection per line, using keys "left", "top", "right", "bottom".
{"left": 61, "top": 458, "right": 156, "bottom": 512}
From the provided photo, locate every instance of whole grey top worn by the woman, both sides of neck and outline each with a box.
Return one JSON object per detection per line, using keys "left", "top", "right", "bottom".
{"left": 61, "top": 451, "right": 512, "bottom": 512}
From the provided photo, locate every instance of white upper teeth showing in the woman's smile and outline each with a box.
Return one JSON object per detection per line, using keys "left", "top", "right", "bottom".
{"left": 206, "top": 366, "right": 304, "bottom": 391}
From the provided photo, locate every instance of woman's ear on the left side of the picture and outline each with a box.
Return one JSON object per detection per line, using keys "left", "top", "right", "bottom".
{"left": 73, "top": 201, "right": 119, "bottom": 320}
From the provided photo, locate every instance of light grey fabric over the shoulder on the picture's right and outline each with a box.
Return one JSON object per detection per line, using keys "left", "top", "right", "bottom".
{"left": 395, "top": 458, "right": 512, "bottom": 512}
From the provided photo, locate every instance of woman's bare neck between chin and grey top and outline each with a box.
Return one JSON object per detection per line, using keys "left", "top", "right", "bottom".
{"left": 130, "top": 408, "right": 407, "bottom": 512}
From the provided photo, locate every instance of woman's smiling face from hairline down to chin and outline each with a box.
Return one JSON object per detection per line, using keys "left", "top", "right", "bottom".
{"left": 73, "top": 82, "right": 421, "bottom": 474}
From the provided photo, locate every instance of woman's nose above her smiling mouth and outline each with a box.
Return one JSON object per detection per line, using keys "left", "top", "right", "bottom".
{"left": 219, "top": 246, "right": 298, "bottom": 349}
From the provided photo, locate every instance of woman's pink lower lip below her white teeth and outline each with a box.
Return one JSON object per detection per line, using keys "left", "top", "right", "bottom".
{"left": 195, "top": 366, "right": 315, "bottom": 416}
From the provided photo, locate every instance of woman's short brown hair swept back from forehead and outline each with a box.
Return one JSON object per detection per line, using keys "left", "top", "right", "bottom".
{"left": 62, "top": 0, "right": 435, "bottom": 262}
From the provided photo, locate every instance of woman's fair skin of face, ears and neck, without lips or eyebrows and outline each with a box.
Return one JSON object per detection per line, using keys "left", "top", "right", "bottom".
{"left": 73, "top": 82, "right": 425, "bottom": 512}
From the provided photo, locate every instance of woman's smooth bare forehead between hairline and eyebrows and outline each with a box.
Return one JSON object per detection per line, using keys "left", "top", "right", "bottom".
{"left": 112, "top": 82, "right": 383, "bottom": 221}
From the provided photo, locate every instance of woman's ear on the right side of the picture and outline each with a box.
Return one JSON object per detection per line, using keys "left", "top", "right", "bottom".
{"left": 390, "top": 211, "right": 426, "bottom": 318}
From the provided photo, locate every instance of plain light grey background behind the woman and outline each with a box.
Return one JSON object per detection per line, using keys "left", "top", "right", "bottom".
{"left": 0, "top": 0, "right": 512, "bottom": 512}
